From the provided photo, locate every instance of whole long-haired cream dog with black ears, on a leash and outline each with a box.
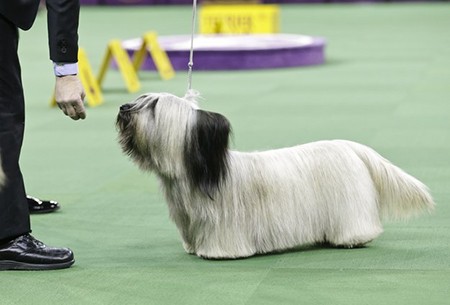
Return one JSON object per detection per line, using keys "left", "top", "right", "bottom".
{"left": 116, "top": 92, "right": 434, "bottom": 259}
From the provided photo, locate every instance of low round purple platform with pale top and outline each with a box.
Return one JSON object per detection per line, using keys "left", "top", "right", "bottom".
{"left": 122, "top": 34, "right": 326, "bottom": 70}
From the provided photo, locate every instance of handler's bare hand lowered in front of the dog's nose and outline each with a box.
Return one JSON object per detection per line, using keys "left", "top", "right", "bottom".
{"left": 55, "top": 75, "right": 86, "bottom": 120}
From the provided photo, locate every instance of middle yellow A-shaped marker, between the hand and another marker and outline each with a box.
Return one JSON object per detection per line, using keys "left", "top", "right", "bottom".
{"left": 98, "top": 39, "right": 141, "bottom": 92}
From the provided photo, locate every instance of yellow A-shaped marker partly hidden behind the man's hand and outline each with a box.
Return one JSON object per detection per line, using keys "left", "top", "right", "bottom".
{"left": 51, "top": 48, "right": 103, "bottom": 107}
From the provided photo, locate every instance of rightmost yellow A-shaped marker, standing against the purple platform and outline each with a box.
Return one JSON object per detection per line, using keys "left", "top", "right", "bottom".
{"left": 133, "top": 32, "right": 175, "bottom": 80}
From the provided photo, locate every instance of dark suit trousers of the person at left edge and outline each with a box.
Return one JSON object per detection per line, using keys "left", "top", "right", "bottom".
{"left": 0, "top": 15, "right": 30, "bottom": 241}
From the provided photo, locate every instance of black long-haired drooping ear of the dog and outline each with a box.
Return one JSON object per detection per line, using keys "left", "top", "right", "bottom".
{"left": 184, "top": 110, "right": 231, "bottom": 199}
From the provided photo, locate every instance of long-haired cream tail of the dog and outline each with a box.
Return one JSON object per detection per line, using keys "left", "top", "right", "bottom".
{"left": 343, "top": 141, "right": 435, "bottom": 220}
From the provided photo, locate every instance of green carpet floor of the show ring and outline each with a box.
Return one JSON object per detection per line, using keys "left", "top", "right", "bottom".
{"left": 0, "top": 3, "right": 450, "bottom": 305}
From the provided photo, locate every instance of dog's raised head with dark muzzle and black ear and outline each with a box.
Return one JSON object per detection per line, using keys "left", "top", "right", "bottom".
{"left": 116, "top": 92, "right": 231, "bottom": 197}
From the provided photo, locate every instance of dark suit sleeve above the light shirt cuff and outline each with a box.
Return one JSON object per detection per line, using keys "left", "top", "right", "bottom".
{"left": 45, "top": 0, "right": 80, "bottom": 63}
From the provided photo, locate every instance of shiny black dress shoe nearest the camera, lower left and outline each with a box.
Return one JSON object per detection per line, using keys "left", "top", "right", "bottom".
{"left": 0, "top": 234, "right": 75, "bottom": 270}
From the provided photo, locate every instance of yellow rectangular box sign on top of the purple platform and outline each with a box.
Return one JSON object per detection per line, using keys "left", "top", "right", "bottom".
{"left": 199, "top": 4, "right": 280, "bottom": 34}
